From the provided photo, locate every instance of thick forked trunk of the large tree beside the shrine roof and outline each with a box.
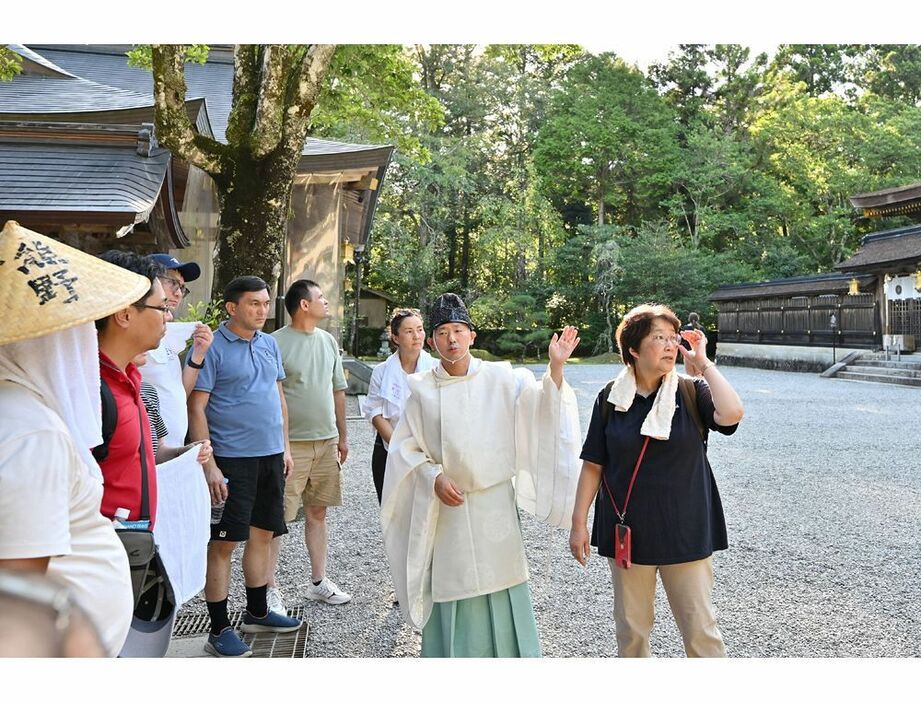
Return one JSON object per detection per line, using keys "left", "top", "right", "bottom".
{"left": 151, "top": 44, "right": 336, "bottom": 295}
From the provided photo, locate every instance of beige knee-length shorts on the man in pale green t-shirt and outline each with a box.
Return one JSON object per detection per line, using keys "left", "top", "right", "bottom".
{"left": 285, "top": 438, "right": 342, "bottom": 522}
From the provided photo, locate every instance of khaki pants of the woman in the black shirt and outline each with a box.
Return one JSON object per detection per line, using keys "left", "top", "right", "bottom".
{"left": 608, "top": 557, "right": 726, "bottom": 658}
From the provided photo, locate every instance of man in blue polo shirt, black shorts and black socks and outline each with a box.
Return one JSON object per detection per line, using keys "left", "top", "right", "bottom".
{"left": 189, "top": 276, "right": 301, "bottom": 657}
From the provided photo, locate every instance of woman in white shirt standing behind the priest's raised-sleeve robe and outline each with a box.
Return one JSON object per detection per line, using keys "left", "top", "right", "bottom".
{"left": 361, "top": 307, "right": 437, "bottom": 504}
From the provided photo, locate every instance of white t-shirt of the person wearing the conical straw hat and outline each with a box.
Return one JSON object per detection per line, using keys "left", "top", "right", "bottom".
{"left": 0, "top": 381, "right": 134, "bottom": 656}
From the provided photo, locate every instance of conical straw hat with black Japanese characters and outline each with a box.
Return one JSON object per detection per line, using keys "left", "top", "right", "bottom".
{"left": 0, "top": 221, "right": 150, "bottom": 344}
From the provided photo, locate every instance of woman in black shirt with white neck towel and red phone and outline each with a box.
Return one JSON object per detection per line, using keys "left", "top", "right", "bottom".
{"left": 569, "top": 305, "right": 743, "bottom": 657}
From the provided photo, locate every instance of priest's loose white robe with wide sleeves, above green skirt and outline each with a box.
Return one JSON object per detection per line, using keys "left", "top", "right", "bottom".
{"left": 381, "top": 359, "right": 581, "bottom": 629}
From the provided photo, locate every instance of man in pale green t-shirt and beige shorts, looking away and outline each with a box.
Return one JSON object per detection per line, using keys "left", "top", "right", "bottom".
{"left": 268, "top": 280, "right": 352, "bottom": 614}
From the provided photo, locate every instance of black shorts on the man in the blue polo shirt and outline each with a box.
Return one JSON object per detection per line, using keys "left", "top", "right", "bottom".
{"left": 211, "top": 453, "right": 288, "bottom": 541}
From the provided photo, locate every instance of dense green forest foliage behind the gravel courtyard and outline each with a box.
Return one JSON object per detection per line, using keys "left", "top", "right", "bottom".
{"left": 81, "top": 44, "right": 921, "bottom": 358}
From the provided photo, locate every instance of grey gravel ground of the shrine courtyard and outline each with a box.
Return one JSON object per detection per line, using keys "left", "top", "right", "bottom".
{"left": 182, "top": 365, "right": 921, "bottom": 657}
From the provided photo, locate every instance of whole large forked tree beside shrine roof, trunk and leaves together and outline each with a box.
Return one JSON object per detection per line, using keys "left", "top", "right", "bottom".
{"left": 130, "top": 44, "right": 440, "bottom": 290}
